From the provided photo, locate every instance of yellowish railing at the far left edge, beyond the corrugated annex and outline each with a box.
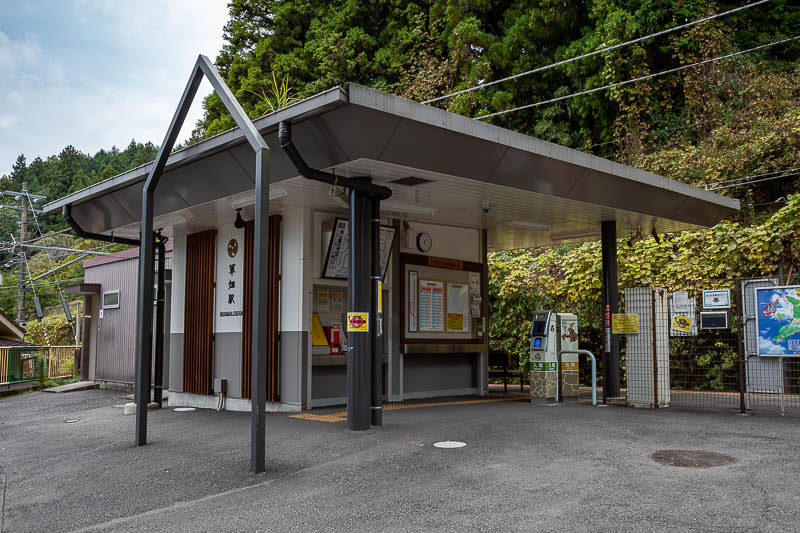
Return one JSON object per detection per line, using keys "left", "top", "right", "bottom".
{"left": 0, "top": 346, "right": 80, "bottom": 385}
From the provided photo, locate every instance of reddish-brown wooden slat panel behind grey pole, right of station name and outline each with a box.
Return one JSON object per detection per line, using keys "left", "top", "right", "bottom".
{"left": 242, "top": 215, "right": 281, "bottom": 402}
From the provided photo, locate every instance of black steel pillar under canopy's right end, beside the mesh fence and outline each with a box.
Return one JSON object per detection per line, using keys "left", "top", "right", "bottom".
{"left": 601, "top": 220, "right": 620, "bottom": 398}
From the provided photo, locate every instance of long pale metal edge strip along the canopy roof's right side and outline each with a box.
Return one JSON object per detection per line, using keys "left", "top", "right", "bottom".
{"left": 348, "top": 83, "right": 740, "bottom": 210}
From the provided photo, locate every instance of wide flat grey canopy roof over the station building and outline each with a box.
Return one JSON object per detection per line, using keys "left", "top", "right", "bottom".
{"left": 44, "top": 84, "right": 739, "bottom": 250}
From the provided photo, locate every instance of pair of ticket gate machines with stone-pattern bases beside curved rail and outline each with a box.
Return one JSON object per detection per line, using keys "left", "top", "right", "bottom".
{"left": 529, "top": 311, "right": 579, "bottom": 398}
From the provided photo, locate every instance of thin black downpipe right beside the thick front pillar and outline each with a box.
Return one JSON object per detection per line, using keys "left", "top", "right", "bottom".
{"left": 370, "top": 196, "right": 383, "bottom": 426}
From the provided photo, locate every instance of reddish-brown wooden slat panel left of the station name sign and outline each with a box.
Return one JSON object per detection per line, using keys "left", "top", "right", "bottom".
{"left": 183, "top": 229, "right": 217, "bottom": 394}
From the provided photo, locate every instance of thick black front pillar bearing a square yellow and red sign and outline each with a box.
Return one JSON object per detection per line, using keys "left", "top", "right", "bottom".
{"left": 347, "top": 179, "right": 375, "bottom": 431}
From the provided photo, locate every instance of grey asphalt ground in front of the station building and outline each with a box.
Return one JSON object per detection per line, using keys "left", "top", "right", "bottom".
{"left": 0, "top": 390, "right": 800, "bottom": 533}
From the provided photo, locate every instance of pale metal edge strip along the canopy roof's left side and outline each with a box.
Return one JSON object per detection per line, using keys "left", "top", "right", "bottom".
{"left": 42, "top": 86, "right": 348, "bottom": 214}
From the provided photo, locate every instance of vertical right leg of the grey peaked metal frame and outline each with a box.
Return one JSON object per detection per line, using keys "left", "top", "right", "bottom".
{"left": 250, "top": 149, "right": 270, "bottom": 472}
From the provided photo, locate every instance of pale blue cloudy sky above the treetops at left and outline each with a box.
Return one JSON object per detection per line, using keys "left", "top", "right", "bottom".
{"left": 0, "top": 0, "right": 228, "bottom": 176}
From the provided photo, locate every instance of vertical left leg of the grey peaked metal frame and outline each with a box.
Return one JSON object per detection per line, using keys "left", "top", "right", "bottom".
{"left": 134, "top": 187, "right": 155, "bottom": 446}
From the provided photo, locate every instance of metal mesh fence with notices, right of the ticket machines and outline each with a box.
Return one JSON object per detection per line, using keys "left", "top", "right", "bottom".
{"left": 621, "top": 277, "right": 800, "bottom": 415}
